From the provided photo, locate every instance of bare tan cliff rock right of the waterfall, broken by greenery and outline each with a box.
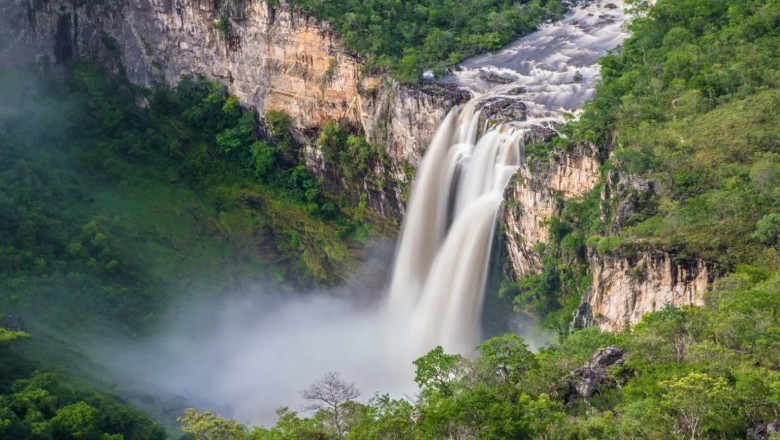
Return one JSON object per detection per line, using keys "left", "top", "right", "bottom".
{"left": 503, "top": 147, "right": 713, "bottom": 331}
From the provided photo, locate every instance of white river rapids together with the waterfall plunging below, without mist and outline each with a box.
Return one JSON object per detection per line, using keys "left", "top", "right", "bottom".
{"left": 388, "top": 1, "right": 627, "bottom": 353}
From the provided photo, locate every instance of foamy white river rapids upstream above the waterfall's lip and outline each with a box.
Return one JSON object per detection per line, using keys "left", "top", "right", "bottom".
{"left": 445, "top": 0, "right": 628, "bottom": 125}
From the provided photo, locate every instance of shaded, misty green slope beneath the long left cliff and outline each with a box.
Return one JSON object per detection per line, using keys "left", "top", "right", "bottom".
{"left": 0, "top": 63, "right": 365, "bottom": 332}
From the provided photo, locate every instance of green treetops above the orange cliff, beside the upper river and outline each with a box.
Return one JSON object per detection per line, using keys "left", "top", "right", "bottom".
{"left": 291, "top": 0, "right": 564, "bottom": 83}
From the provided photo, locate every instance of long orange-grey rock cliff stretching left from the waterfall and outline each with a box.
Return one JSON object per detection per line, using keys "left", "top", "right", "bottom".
{"left": 6, "top": 0, "right": 468, "bottom": 222}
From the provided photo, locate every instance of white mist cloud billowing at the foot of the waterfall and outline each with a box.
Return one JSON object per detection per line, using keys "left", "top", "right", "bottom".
{"left": 99, "top": 278, "right": 423, "bottom": 425}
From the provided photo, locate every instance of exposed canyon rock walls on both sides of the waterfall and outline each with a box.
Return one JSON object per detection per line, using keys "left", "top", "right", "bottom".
{"left": 0, "top": 0, "right": 713, "bottom": 330}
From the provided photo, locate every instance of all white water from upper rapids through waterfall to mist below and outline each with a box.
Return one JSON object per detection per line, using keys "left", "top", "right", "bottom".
{"left": 104, "top": 1, "right": 626, "bottom": 424}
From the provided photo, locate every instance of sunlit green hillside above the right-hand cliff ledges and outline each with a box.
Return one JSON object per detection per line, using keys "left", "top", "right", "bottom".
{"left": 574, "top": 0, "right": 780, "bottom": 271}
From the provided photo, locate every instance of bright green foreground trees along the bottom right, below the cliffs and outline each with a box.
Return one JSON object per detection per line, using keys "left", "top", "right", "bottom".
{"left": 181, "top": 276, "right": 780, "bottom": 439}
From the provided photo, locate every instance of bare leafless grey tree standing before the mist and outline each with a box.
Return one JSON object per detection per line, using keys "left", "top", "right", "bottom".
{"left": 301, "top": 371, "right": 360, "bottom": 438}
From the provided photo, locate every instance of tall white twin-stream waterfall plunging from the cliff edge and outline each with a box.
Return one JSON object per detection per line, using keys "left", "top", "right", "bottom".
{"left": 388, "top": 99, "right": 523, "bottom": 353}
